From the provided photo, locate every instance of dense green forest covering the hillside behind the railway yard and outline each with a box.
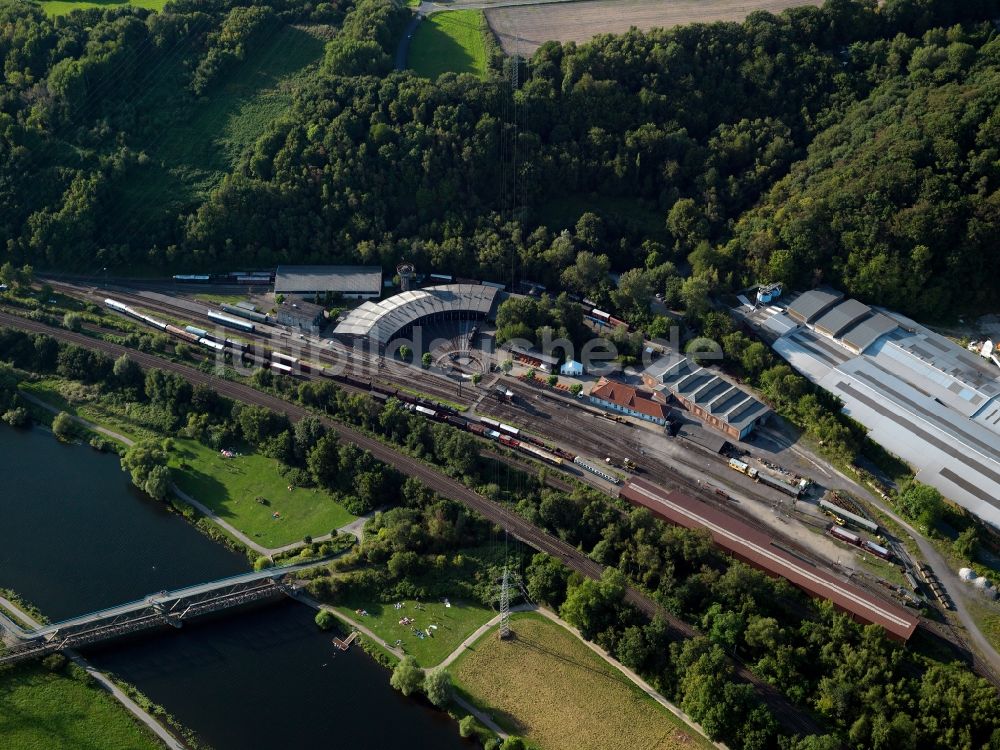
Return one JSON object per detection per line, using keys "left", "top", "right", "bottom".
{"left": 0, "top": 0, "right": 1000, "bottom": 316}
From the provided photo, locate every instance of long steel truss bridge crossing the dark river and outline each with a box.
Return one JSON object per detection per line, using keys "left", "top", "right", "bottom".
{"left": 0, "top": 561, "right": 325, "bottom": 665}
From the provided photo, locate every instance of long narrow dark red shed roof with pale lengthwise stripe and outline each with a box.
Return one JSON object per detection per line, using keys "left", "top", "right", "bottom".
{"left": 619, "top": 478, "right": 919, "bottom": 641}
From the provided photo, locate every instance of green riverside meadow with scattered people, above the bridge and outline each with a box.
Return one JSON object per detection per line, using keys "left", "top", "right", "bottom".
{"left": 170, "top": 440, "right": 355, "bottom": 547}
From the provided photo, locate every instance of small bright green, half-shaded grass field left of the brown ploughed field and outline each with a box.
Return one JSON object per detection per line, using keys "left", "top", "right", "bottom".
{"left": 408, "top": 10, "right": 486, "bottom": 78}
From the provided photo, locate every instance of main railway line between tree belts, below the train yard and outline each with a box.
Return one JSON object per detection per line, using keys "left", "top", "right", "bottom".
{"left": 0, "top": 313, "right": 820, "bottom": 734}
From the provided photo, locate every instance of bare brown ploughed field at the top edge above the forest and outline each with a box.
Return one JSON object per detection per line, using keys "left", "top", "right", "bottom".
{"left": 486, "top": 0, "right": 822, "bottom": 57}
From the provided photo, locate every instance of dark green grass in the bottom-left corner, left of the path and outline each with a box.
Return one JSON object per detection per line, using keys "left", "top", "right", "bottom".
{"left": 0, "top": 663, "right": 162, "bottom": 750}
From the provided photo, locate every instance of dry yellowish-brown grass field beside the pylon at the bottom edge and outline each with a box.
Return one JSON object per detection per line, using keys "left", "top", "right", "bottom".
{"left": 451, "top": 614, "right": 711, "bottom": 750}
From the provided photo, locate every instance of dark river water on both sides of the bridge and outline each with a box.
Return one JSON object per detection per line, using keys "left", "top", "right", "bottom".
{"left": 0, "top": 425, "right": 471, "bottom": 750}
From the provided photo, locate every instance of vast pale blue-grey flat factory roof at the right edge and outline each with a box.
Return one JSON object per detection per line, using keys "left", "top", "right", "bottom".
{"left": 774, "top": 296, "right": 1000, "bottom": 527}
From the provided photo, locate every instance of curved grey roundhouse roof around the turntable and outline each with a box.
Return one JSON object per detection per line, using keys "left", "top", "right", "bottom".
{"left": 333, "top": 284, "right": 500, "bottom": 346}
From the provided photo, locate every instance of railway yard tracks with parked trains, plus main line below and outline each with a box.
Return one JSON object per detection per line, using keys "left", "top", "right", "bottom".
{"left": 0, "top": 274, "right": 1000, "bottom": 692}
